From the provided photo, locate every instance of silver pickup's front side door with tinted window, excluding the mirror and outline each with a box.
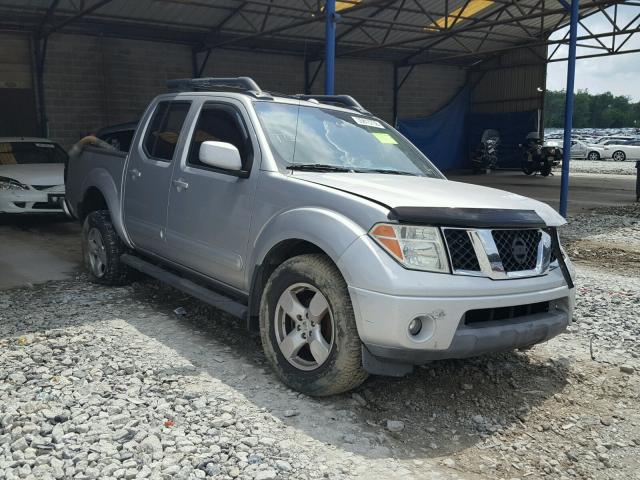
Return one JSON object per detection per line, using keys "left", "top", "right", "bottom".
{"left": 167, "top": 99, "right": 259, "bottom": 289}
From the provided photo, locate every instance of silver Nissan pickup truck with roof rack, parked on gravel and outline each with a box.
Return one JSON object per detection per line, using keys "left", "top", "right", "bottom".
{"left": 66, "top": 77, "right": 575, "bottom": 395}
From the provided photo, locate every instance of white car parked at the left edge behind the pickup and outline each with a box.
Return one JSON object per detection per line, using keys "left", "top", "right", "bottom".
{"left": 0, "top": 137, "right": 68, "bottom": 213}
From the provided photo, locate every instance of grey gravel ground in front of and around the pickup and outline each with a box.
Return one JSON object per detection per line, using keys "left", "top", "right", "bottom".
{"left": 0, "top": 207, "right": 640, "bottom": 480}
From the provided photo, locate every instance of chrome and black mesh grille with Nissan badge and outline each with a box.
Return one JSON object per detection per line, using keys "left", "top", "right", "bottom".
{"left": 442, "top": 228, "right": 552, "bottom": 280}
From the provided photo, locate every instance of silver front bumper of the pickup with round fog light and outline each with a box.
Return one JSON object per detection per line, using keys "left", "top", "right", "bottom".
{"left": 349, "top": 280, "right": 575, "bottom": 364}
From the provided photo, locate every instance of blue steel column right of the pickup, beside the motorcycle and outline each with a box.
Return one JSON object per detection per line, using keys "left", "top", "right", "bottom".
{"left": 560, "top": 0, "right": 580, "bottom": 218}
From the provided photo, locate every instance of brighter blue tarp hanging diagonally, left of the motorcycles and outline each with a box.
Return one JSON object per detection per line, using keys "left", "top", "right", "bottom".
{"left": 398, "top": 87, "right": 470, "bottom": 170}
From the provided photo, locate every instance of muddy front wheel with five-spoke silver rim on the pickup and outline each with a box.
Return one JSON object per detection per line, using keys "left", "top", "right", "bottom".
{"left": 260, "top": 254, "right": 367, "bottom": 396}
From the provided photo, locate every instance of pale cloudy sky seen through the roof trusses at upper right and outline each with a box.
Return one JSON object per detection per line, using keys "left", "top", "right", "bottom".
{"left": 547, "top": 5, "right": 640, "bottom": 102}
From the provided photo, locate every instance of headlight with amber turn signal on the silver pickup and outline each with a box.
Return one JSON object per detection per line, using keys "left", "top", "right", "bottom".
{"left": 369, "top": 223, "right": 449, "bottom": 273}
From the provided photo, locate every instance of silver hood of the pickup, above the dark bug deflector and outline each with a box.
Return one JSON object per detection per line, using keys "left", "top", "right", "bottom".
{"left": 294, "top": 172, "right": 566, "bottom": 227}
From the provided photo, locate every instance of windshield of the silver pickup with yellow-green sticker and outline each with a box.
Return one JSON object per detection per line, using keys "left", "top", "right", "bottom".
{"left": 255, "top": 102, "right": 444, "bottom": 178}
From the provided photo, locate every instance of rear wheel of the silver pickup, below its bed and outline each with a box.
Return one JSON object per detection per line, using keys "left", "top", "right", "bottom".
{"left": 82, "top": 210, "right": 134, "bottom": 286}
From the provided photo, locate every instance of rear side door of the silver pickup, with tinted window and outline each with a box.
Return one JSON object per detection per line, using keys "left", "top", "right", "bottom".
{"left": 123, "top": 100, "right": 191, "bottom": 255}
